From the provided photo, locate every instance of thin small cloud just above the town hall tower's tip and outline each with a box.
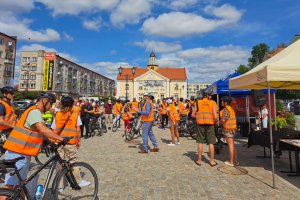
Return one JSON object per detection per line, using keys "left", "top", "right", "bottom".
{"left": 134, "top": 40, "right": 181, "bottom": 53}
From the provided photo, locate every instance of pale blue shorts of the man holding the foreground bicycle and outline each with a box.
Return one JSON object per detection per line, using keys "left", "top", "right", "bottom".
{"left": 4, "top": 150, "right": 31, "bottom": 185}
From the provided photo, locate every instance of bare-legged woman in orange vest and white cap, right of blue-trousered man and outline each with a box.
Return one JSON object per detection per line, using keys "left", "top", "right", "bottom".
{"left": 167, "top": 99, "right": 180, "bottom": 146}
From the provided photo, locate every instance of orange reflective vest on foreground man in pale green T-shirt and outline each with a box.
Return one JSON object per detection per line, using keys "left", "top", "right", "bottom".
{"left": 3, "top": 106, "right": 43, "bottom": 156}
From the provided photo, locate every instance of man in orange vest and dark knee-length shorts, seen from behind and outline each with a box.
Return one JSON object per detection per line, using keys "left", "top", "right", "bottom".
{"left": 192, "top": 91, "right": 217, "bottom": 167}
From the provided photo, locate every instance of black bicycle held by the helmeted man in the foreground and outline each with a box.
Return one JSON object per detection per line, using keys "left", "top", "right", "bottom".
{"left": 0, "top": 138, "right": 99, "bottom": 200}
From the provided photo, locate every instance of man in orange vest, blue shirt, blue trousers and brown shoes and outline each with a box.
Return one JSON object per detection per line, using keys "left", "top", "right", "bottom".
{"left": 135, "top": 94, "right": 159, "bottom": 154}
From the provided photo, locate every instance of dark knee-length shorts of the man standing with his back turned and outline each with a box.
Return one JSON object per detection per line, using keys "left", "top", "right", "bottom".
{"left": 196, "top": 124, "right": 216, "bottom": 144}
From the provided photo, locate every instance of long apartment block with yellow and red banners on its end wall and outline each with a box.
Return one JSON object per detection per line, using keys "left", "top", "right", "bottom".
{"left": 19, "top": 50, "right": 115, "bottom": 97}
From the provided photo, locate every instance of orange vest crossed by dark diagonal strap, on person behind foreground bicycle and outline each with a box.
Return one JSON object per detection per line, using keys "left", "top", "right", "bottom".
{"left": 54, "top": 111, "right": 79, "bottom": 144}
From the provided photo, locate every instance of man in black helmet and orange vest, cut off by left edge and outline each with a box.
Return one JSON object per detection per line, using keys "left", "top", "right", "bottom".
{"left": 0, "top": 86, "right": 17, "bottom": 138}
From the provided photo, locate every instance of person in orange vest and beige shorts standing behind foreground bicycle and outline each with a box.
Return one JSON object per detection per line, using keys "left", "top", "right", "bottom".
{"left": 51, "top": 96, "right": 87, "bottom": 192}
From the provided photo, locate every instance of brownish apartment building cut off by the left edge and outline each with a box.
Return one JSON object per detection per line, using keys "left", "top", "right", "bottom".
{"left": 0, "top": 32, "right": 17, "bottom": 88}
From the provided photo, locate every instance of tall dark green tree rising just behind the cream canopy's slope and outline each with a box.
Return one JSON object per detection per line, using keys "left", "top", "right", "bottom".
{"left": 248, "top": 43, "right": 270, "bottom": 69}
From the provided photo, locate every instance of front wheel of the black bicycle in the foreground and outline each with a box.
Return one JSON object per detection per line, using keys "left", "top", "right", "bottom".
{"left": 52, "top": 162, "right": 99, "bottom": 200}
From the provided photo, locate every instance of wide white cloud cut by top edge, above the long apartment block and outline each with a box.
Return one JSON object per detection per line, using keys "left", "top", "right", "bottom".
{"left": 36, "top": 0, "right": 120, "bottom": 16}
